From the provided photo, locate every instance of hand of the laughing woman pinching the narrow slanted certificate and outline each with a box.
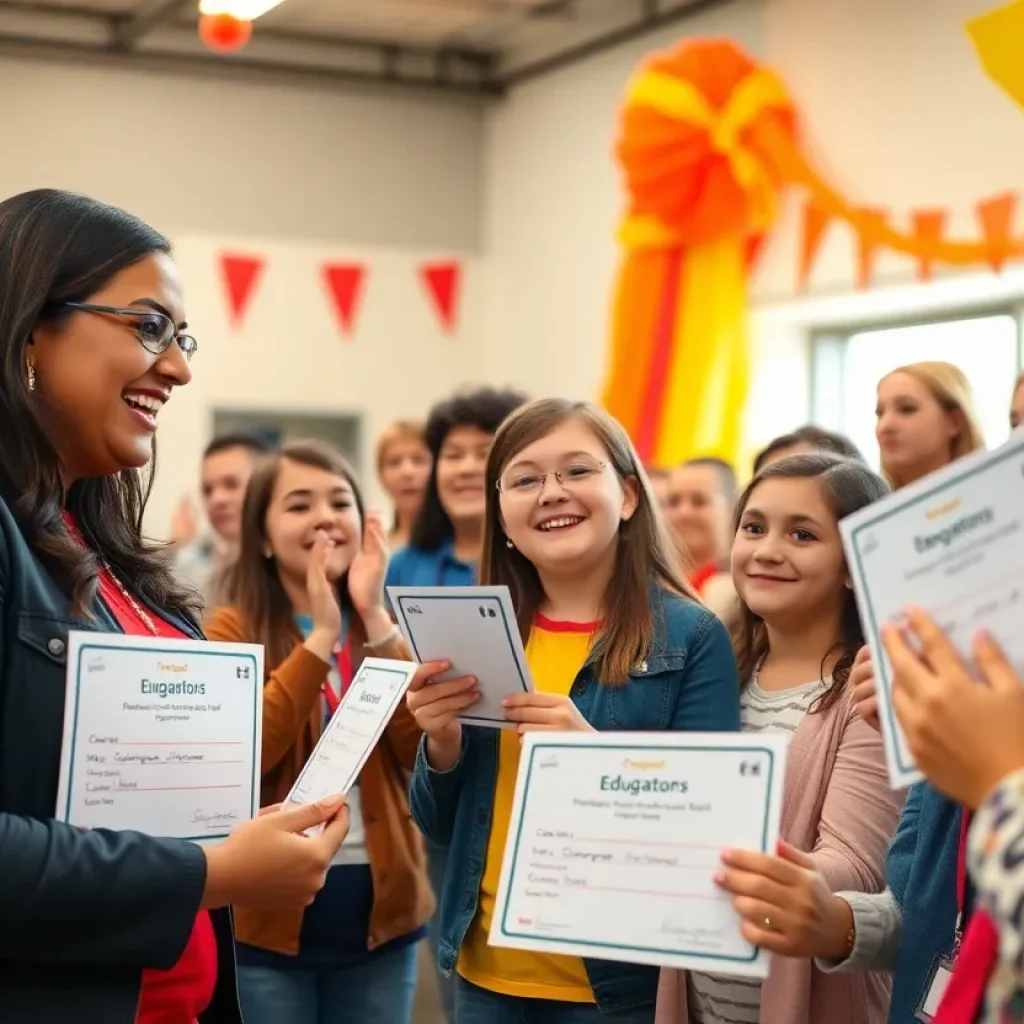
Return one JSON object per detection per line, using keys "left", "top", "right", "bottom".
{"left": 203, "top": 797, "right": 348, "bottom": 909}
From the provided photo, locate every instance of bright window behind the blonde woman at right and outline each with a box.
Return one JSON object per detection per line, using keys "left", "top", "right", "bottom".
{"left": 811, "top": 308, "right": 1021, "bottom": 467}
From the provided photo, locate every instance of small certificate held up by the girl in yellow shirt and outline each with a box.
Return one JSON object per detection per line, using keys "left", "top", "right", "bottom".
{"left": 387, "top": 587, "right": 534, "bottom": 729}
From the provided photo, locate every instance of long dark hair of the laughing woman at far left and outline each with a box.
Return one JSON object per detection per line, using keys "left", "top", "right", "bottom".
{"left": 0, "top": 188, "right": 200, "bottom": 615}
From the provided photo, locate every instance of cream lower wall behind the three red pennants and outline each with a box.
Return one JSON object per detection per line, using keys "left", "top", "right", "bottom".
{"left": 147, "top": 234, "right": 484, "bottom": 534}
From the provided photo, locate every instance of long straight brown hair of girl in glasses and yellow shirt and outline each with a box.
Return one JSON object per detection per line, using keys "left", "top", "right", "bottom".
{"left": 480, "top": 398, "right": 696, "bottom": 683}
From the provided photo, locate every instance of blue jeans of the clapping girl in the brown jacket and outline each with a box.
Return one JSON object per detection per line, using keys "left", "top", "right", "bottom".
{"left": 239, "top": 942, "right": 418, "bottom": 1024}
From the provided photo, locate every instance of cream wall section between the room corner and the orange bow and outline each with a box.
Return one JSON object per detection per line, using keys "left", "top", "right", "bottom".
{"left": 483, "top": 0, "right": 764, "bottom": 407}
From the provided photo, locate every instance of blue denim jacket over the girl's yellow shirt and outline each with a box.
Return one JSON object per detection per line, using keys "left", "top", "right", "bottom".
{"left": 410, "top": 588, "right": 739, "bottom": 1013}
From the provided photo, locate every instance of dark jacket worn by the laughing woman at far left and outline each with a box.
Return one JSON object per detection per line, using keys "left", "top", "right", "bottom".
{"left": 0, "top": 497, "right": 242, "bottom": 1024}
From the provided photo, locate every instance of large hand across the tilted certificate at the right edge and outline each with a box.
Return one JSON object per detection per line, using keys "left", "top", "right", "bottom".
{"left": 882, "top": 609, "right": 1024, "bottom": 808}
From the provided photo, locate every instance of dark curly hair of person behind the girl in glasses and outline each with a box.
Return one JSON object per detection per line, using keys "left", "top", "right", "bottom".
{"left": 410, "top": 387, "right": 526, "bottom": 551}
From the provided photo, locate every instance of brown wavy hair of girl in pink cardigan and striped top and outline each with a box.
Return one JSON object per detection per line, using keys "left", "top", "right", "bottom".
{"left": 730, "top": 452, "right": 889, "bottom": 712}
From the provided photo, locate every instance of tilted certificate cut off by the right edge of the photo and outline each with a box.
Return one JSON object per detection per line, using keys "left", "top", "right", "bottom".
{"left": 840, "top": 433, "right": 1024, "bottom": 788}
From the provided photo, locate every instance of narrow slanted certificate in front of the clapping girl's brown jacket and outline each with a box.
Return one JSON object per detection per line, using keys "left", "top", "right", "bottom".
{"left": 286, "top": 657, "right": 418, "bottom": 804}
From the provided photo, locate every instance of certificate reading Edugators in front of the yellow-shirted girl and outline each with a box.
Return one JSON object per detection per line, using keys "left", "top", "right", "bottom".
{"left": 489, "top": 732, "right": 788, "bottom": 978}
